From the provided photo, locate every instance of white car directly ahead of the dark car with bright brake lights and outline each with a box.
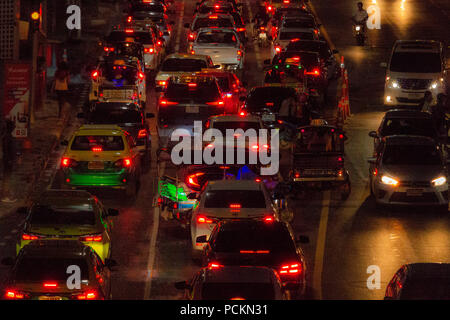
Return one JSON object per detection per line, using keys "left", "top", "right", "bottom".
{"left": 191, "top": 180, "right": 278, "bottom": 260}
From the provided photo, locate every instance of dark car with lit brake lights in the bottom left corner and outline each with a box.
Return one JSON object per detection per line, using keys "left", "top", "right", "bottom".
{"left": 2, "top": 240, "right": 117, "bottom": 300}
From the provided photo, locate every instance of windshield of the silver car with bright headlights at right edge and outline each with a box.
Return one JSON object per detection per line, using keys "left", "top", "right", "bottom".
{"left": 383, "top": 145, "right": 442, "bottom": 166}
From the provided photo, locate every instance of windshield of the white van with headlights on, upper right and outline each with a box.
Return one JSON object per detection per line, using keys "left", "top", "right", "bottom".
{"left": 390, "top": 52, "right": 441, "bottom": 73}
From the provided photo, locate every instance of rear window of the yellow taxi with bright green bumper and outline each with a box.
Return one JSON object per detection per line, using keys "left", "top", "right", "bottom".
{"left": 70, "top": 136, "right": 125, "bottom": 151}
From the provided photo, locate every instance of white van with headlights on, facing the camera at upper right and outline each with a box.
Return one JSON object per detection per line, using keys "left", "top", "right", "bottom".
{"left": 381, "top": 40, "right": 447, "bottom": 106}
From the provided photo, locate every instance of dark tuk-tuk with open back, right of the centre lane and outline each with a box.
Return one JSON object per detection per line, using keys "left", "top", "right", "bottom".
{"left": 289, "top": 119, "right": 351, "bottom": 200}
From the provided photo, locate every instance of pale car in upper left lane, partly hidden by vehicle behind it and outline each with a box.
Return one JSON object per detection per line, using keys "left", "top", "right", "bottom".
{"left": 105, "top": 28, "right": 162, "bottom": 71}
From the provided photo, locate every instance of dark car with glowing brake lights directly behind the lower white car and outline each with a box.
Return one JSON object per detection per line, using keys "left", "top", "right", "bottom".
{"left": 197, "top": 219, "right": 308, "bottom": 298}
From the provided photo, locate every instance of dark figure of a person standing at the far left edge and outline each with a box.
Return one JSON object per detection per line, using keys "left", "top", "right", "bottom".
{"left": 1, "top": 117, "right": 17, "bottom": 202}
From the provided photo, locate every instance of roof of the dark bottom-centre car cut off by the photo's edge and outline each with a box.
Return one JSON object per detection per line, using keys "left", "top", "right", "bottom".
{"left": 204, "top": 266, "right": 276, "bottom": 283}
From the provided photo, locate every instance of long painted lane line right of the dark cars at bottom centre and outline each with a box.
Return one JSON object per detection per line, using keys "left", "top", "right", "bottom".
{"left": 313, "top": 190, "right": 331, "bottom": 300}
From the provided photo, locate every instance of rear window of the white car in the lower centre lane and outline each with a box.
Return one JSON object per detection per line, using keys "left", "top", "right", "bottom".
{"left": 205, "top": 190, "right": 266, "bottom": 209}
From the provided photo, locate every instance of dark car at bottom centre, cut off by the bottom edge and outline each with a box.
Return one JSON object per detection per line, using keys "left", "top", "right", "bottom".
{"left": 175, "top": 265, "right": 288, "bottom": 300}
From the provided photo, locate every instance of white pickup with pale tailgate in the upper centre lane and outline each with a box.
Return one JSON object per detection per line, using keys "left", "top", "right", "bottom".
{"left": 191, "top": 28, "right": 245, "bottom": 71}
